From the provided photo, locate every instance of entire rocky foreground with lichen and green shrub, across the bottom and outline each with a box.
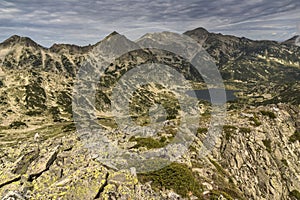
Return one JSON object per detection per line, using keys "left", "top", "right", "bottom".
{"left": 0, "top": 104, "right": 300, "bottom": 199}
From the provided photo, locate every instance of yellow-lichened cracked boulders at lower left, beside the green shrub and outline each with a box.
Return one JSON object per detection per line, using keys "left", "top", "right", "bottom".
{"left": 0, "top": 129, "right": 162, "bottom": 199}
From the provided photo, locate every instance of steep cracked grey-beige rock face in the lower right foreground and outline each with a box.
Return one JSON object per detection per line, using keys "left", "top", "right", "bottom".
{"left": 212, "top": 105, "right": 300, "bottom": 199}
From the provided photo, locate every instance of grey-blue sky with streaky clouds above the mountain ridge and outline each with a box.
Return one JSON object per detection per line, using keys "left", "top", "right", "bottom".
{"left": 0, "top": 0, "right": 300, "bottom": 47}
